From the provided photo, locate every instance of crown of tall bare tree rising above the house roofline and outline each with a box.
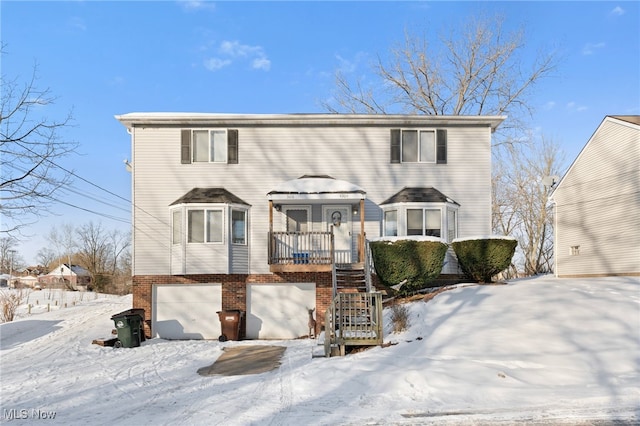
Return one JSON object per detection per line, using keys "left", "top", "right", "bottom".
{"left": 323, "top": 16, "right": 557, "bottom": 137}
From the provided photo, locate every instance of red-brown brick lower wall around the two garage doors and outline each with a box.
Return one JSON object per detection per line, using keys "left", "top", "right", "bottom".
{"left": 132, "top": 272, "right": 333, "bottom": 337}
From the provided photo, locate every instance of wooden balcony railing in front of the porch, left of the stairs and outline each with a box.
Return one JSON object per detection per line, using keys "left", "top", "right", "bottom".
{"left": 269, "top": 232, "right": 334, "bottom": 265}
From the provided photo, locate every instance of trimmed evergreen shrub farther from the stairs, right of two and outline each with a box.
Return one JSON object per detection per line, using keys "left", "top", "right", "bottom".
{"left": 451, "top": 237, "right": 518, "bottom": 283}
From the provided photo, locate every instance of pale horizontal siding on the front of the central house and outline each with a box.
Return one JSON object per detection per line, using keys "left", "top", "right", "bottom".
{"left": 133, "top": 120, "right": 491, "bottom": 275}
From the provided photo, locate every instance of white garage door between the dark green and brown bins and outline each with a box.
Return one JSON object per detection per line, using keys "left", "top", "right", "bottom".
{"left": 151, "top": 284, "right": 222, "bottom": 340}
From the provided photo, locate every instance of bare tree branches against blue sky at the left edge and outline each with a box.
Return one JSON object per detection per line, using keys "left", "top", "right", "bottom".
{"left": 0, "top": 46, "right": 77, "bottom": 235}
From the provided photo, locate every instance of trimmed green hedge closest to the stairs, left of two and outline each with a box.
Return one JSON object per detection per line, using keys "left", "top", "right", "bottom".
{"left": 369, "top": 239, "right": 448, "bottom": 294}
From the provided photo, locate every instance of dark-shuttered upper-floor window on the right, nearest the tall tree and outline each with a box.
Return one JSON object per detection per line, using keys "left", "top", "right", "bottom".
{"left": 391, "top": 129, "right": 447, "bottom": 164}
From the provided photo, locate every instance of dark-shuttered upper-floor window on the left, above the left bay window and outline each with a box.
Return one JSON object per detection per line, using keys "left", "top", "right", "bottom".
{"left": 180, "top": 129, "right": 238, "bottom": 164}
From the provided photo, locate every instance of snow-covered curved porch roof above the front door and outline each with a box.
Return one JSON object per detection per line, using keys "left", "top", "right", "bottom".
{"left": 267, "top": 175, "right": 366, "bottom": 201}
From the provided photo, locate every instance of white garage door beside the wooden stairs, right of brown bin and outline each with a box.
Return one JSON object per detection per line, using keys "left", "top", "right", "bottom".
{"left": 247, "top": 283, "right": 316, "bottom": 339}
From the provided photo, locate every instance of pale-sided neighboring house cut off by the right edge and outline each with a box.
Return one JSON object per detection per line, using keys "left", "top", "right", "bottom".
{"left": 551, "top": 115, "right": 640, "bottom": 277}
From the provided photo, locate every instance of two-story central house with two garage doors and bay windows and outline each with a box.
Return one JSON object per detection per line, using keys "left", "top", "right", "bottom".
{"left": 116, "top": 113, "right": 504, "bottom": 339}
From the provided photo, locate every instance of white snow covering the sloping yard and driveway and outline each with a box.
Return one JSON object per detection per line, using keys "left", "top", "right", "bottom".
{"left": 0, "top": 276, "right": 640, "bottom": 425}
